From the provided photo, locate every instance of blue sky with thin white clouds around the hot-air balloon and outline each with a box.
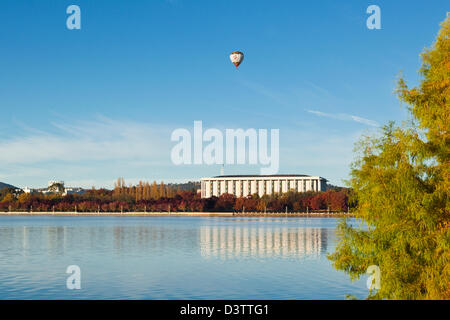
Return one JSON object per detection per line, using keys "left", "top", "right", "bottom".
{"left": 0, "top": 0, "right": 450, "bottom": 187}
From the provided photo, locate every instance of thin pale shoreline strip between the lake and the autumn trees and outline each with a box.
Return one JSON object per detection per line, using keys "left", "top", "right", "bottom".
{"left": 0, "top": 211, "right": 353, "bottom": 218}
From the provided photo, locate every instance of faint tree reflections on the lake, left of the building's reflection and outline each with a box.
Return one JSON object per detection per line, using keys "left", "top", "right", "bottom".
{"left": 4, "top": 226, "right": 199, "bottom": 256}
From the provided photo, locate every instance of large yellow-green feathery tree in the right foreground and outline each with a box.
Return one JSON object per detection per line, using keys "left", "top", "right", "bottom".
{"left": 329, "top": 18, "right": 450, "bottom": 299}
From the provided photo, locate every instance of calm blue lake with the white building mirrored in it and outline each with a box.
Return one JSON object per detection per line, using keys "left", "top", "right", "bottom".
{"left": 0, "top": 216, "right": 368, "bottom": 299}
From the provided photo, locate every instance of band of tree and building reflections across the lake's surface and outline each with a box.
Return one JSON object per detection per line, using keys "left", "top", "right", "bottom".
{"left": 0, "top": 225, "right": 327, "bottom": 259}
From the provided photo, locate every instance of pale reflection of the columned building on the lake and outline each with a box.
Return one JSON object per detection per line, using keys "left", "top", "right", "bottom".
{"left": 200, "top": 226, "right": 327, "bottom": 258}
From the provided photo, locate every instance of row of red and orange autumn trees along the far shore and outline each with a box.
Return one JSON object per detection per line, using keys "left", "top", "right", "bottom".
{"left": 0, "top": 179, "right": 349, "bottom": 212}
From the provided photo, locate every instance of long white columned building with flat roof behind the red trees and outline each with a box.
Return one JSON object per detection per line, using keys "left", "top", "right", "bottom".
{"left": 201, "top": 174, "right": 327, "bottom": 198}
